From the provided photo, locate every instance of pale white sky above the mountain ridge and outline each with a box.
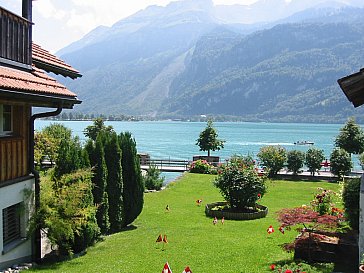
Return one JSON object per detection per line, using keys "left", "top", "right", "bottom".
{"left": 0, "top": 0, "right": 257, "bottom": 53}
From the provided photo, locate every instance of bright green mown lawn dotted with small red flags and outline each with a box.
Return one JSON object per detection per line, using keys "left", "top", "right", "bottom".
{"left": 32, "top": 174, "right": 339, "bottom": 273}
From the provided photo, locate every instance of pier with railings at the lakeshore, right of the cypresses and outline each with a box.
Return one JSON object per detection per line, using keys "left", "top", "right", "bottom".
{"left": 140, "top": 159, "right": 192, "bottom": 172}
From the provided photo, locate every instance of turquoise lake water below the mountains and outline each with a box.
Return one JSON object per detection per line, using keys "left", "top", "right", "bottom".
{"left": 35, "top": 120, "right": 361, "bottom": 180}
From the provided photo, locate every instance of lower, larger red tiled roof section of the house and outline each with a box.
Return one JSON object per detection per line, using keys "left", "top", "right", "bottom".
{"left": 0, "top": 66, "right": 76, "bottom": 98}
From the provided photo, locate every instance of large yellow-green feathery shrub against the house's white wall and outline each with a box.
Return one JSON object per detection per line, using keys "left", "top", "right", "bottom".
{"left": 29, "top": 169, "right": 100, "bottom": 255}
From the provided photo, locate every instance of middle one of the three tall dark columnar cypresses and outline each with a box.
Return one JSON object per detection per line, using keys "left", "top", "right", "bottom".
{"left": 105, "top": 132, "right": 125, "bottom": 232}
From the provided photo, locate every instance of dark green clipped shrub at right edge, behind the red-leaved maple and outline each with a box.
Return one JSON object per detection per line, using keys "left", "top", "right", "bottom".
{"left": 342, "top": 178, "right": 360, "bottom": 230}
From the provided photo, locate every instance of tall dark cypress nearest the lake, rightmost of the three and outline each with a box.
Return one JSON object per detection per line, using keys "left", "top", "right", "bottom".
{"left": 119, "top": 132, "right": 144, "bottom": 225}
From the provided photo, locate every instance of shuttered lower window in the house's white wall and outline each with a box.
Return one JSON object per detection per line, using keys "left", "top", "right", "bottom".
{"left": 3, "top": 203, "right": 21, "bottom": 246}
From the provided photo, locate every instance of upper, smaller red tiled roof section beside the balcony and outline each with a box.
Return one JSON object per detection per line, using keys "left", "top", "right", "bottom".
{"left": 32, "top": 43, "right": 81, "bottom": 78}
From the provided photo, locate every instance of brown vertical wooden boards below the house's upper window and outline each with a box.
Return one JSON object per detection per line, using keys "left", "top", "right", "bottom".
{"left": 0, "top": 138, "right": 27, "bottom": 183}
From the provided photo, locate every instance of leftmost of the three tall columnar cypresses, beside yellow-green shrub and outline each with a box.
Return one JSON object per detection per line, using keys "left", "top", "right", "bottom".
{"left": 85, "top": 134, "right": 110, "bottom": 234}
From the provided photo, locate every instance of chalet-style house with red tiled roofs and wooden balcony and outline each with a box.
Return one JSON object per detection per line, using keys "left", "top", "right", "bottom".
{"left": 0, "top": 0, "right": 81, "bottom": 269}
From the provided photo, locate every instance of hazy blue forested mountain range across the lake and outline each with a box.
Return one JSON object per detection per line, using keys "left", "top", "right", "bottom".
{"left": 57, "top": 0, "right": 364, "bottom": 122}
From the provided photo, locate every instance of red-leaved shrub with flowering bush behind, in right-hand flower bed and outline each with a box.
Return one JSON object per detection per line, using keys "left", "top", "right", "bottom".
{"left": 278, "top": 188, "right": 346, "bottom": 262}
